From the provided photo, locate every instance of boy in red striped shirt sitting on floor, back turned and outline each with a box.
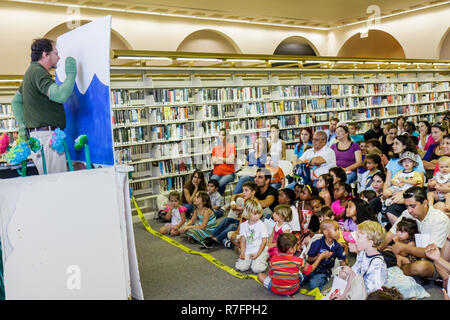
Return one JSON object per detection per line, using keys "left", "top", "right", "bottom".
{"left": 258, "top": 233, "right": 327, "bottom": 296}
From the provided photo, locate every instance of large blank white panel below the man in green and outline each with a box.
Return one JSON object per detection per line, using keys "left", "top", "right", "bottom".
{"left": 0, "top": 166, "right": 143, "bottom": 300}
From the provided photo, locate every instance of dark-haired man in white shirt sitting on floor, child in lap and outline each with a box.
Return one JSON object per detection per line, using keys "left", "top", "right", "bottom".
{"left": 379, "top": 187, "right": 450, "bottom": 277}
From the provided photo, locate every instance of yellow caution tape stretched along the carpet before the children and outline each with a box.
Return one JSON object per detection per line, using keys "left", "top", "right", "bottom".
{"left": 131, "top": 197, "right": 323, "bottom": 300}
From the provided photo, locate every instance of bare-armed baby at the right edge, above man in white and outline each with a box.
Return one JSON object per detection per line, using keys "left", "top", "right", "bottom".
{"left": 427, "top": 156, "right": 450, "bottom": 212}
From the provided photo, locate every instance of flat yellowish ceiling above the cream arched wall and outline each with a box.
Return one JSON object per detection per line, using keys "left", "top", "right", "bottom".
{"left": 12, "top": 0, "right": 449, "bottom": 28}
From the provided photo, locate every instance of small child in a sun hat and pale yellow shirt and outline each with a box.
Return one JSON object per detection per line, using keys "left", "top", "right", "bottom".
{"left": 391, "top": 151, "right": 424, "bottom": 193}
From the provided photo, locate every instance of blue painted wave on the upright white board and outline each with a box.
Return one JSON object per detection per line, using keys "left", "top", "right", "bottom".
{"left": 56, "top": 74, "right": 114, "bottom": 165}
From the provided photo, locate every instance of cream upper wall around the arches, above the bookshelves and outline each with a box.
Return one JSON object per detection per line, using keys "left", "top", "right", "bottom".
{"left": 0, "top": 2, "right": 450, "bottom": 74}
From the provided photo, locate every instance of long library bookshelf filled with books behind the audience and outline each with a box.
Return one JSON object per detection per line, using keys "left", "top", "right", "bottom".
{"left": 0, "top": 50, "right": 450, "bottom": 213}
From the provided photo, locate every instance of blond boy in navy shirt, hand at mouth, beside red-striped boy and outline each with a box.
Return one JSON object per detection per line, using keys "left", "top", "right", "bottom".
{"left": 304, "top": 219, "right": 347, "bottom": 290}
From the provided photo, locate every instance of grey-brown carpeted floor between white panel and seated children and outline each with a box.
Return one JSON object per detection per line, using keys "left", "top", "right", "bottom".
{"left": 134, "top": 215, "right": 442, "bottom": 300}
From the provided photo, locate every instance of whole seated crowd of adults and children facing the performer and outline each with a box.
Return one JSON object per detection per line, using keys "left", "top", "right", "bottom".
{"left": 159, "top": 114, "right": 450, "bottom": 300}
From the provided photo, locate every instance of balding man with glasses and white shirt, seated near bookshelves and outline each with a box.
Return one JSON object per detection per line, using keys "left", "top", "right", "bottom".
{"left": 300, "top": 131, "right": 336, "bottom": 185}
